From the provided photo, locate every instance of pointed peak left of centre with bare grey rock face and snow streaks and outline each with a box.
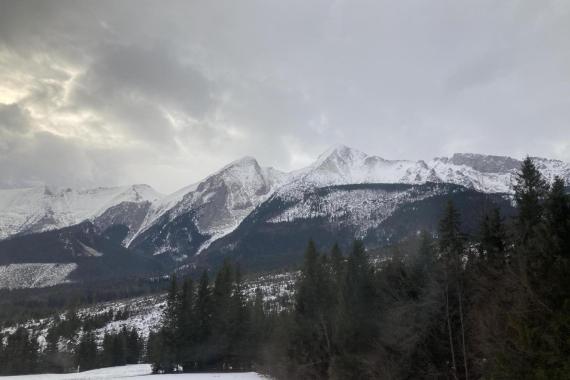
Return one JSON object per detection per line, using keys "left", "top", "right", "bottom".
{"left": 129, "top": 157, "right": 287, "bottom": 256}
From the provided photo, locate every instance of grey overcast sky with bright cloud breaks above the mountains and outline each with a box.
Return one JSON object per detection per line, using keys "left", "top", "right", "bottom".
{"left": 0, "top": 0, "right": 570, "bottom": 192}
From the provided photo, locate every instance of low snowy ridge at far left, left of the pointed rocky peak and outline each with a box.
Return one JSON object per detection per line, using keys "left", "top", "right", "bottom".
{"left": 0, "top": 185, "right": 162, "bottom": 239}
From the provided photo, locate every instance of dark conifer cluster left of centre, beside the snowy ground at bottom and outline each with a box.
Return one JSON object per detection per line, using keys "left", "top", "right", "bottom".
{"left": 144, "top": 261, "right": 266, "bottom": 373}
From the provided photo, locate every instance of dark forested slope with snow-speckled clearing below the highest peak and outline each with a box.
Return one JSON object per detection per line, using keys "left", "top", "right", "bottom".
{"left": 201, "top": 183, "right": 512, "bottom": 270}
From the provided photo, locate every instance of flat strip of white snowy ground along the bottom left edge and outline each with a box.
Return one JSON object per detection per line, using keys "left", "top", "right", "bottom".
{"left": 2, "top": 364, "right": 268, "bottom": 380}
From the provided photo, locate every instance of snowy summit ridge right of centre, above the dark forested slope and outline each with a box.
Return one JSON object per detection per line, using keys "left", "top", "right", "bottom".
{"left": 280, "top": 145, "right": 570, "bottom": 193}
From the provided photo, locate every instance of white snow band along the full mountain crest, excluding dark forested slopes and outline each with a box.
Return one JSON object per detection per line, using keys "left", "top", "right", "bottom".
{"left": 0, "top": 145, "right": 570, "bottom": 254}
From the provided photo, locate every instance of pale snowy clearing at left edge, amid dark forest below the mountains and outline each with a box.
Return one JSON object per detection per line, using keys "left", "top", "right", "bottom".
{"left": 0, "top": 263, "right": 77, "bottom": 289}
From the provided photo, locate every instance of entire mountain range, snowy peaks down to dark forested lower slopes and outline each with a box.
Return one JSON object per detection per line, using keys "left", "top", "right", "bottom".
{"left": 0, "top": 145, "right": 570, "bottom": 286}
